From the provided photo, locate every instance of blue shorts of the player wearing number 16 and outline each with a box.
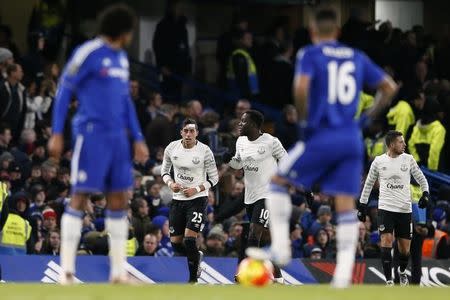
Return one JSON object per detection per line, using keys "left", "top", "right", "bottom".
{"left": 278, "top": 128, "right": 364, "bottom": 197}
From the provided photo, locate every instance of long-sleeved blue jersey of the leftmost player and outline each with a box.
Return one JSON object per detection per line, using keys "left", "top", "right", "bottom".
{"left": 52, "top": 38, "right": 142, "bottom": 139}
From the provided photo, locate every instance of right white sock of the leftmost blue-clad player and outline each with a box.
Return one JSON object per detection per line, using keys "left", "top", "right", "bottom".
{"left": 105, "top": 210, "right": 128, "bottom": 280}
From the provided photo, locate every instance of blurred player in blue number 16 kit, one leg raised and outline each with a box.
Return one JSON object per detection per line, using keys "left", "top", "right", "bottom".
{"left": 248, "top": 10, "right": 396, "bottom": 288}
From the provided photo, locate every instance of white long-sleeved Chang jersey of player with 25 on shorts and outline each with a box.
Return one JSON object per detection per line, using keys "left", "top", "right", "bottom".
{"left": 161, "top": 140, "right": 219, "bottom": 200}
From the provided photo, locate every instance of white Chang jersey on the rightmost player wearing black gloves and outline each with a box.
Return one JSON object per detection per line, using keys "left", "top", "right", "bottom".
{"left": 360, "top": 153, "right": 428, "bottom": 213}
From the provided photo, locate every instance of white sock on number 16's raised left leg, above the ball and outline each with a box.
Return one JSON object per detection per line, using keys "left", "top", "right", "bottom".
{"left": 266, "top": 185, "right": 292, "bottom": 266}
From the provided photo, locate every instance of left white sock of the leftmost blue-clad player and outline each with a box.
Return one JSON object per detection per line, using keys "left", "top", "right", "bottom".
{"left": 60, "top": 207, "right": 83, "bottom": 276}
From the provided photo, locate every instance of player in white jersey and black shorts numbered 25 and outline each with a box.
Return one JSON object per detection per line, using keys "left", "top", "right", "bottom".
{"left": 161, "top": 119, "right": 219, "bottom": 283}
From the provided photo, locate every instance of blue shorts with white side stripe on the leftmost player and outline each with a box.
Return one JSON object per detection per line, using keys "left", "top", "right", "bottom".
{"left": 70, "top": 129, "right": 133, "bottom": 193}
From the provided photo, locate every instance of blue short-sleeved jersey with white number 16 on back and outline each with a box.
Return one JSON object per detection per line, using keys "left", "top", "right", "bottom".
{"left": 295, "top": 41, "right": 385, "bottom": 130}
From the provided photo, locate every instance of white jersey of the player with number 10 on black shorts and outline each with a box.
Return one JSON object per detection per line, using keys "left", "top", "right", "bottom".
{"left": 229, "top": 133, "right": 286, "bottom": 204}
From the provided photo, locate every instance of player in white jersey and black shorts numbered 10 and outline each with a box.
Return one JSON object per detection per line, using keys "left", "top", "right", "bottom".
{"left": 229, "top": 110, "right": 286, "bottom": 282}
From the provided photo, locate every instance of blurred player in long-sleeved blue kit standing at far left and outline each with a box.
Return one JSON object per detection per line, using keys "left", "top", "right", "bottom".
{"left": 48, "top": 5, "right": 148, "bottom": 284}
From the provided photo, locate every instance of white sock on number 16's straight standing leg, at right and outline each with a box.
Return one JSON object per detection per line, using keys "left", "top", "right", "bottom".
{"left": 332, "top": 211, "right": 359, "bottom": 288}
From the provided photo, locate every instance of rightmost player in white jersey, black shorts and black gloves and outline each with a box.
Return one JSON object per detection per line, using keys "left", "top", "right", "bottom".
{"left": 358, "top": 130, "right": 429, "bottom": 286}
